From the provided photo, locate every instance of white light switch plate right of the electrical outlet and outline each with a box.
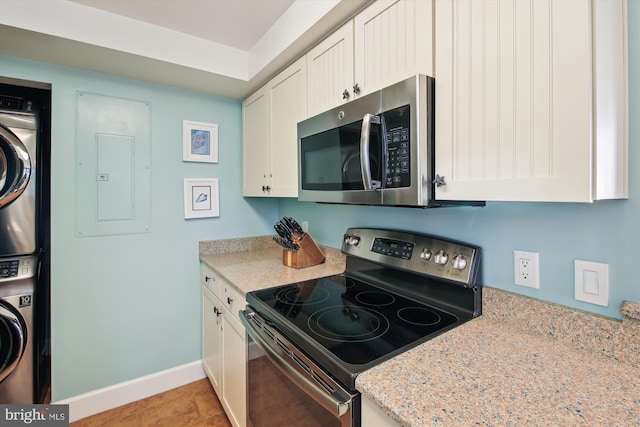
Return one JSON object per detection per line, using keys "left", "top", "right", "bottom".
{"left": 575, "top": 260, "right": 609, "bottom": 307}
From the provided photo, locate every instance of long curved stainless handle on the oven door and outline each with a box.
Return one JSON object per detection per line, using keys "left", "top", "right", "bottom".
{"left": 240, "top": 311, "right": 351, "bottom": 418}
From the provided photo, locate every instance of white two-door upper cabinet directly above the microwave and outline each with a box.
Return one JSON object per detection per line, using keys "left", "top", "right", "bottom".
{"left": 307, "top": 0, "right": 433, "bottom": 116}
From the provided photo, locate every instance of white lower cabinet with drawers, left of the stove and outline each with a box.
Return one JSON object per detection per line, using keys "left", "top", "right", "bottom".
{"left": 200, "top": 264, "right": 247, "bottom": 427}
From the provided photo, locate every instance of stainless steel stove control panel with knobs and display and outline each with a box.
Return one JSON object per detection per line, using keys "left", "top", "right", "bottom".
{"left": 342, "top": 228, "right": 480, "bottom": 286}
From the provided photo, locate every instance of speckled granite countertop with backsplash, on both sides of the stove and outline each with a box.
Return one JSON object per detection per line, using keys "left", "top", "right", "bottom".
{"left": 200, "top": 236, "right": 640, "bottom": 426}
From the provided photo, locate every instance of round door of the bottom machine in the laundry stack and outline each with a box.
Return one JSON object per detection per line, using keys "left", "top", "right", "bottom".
{"left": 0, "top": 302, "right": 27, "bottom": 382}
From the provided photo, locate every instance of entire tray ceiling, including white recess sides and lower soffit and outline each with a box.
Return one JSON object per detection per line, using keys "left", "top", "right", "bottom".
{"left": 0, "top": 0, "right": 373, "bottom": 99}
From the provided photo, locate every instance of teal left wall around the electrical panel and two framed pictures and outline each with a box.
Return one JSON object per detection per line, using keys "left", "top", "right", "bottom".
{"left": 0, "top": 56, "right": 277, "bottom": 401}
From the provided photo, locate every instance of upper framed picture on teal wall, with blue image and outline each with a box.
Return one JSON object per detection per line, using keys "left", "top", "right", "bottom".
{"left": 182, "top": 120, "right": 218, "bottom": 163}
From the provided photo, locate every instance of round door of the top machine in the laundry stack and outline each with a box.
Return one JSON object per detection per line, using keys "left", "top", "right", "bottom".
{"left": 0, "top": 124, "right": 31, "bottom": 209}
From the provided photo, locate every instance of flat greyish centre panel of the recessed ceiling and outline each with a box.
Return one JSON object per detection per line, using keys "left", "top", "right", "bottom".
{"left": 72, "top": 0, "right": 294, "bottom": 50}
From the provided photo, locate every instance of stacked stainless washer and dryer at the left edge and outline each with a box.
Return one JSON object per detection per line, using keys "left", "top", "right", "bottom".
{"left": 0, "top": 90, "right": 49, "bottom": 404}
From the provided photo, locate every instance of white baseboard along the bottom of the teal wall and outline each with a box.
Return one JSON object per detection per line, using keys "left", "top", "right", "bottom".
{"left": 52, "top": 360, "right": 206, "bottom": 422}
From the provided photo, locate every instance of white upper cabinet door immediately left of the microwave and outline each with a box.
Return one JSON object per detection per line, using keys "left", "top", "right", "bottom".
{"left": 269, "top": 57, "right": 307, "bottom": 197}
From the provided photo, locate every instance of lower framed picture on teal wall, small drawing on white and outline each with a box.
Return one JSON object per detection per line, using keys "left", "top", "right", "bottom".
{"left": 184, "top": 178, "right": 220, "bottom": 219}
